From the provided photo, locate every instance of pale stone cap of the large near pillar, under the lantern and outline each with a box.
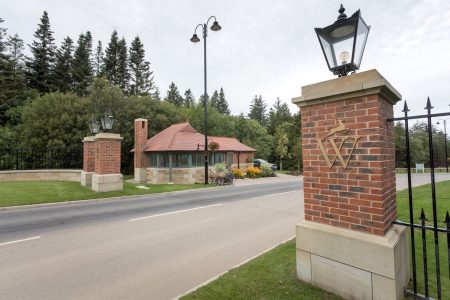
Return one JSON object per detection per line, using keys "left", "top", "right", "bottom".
{"left": 292, "top": 69, "right": 402, "bottom": 107}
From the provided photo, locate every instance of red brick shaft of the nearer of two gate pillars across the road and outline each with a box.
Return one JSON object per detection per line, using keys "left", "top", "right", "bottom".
{"left": 95, "top": 139, "right": 121, "bottom": 175}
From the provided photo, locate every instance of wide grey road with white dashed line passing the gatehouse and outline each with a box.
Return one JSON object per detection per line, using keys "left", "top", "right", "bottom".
{"left": 0, "top": 174, "right": 450, "bottom": 299}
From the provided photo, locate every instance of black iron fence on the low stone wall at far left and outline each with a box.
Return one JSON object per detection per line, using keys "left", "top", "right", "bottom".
{"left": 0, "top": 147, "right": 83, "bottom": 170}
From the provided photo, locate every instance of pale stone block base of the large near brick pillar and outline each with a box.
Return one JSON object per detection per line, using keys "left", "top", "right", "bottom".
{"left": 296, "top": 221, "right": 409, "bottom": 299}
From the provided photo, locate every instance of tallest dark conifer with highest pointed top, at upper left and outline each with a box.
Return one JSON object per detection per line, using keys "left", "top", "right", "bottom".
{"left": 26, "top": 11, "right": 56, "bottom": 93}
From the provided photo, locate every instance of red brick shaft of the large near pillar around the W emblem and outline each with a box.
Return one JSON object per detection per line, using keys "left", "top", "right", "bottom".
{"left": 300, "top": 95, "right": 396, "bottom": 236}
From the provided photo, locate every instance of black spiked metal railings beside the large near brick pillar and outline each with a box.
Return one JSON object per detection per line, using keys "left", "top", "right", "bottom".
{"left": 388, "top": 98, "right": 450, "bottom": 299}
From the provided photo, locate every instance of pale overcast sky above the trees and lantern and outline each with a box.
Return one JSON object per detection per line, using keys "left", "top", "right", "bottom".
{"left": 0, "top": 0, "right": 450, "bottom": 120}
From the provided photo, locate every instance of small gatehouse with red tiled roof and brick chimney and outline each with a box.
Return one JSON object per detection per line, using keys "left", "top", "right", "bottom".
{"left": 133, "top": 119, "right": 256, "bottom": 183}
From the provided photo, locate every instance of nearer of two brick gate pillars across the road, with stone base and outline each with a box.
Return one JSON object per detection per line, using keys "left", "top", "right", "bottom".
{"left": 92, "top": 133, "right": 123, "bottom": 192}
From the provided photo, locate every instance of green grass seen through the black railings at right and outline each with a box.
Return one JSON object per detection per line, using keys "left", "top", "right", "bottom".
{"left": 397, "top": 181, "right": 450, "bottom": 299}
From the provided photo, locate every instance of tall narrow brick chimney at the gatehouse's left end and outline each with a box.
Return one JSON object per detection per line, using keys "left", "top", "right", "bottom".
{"left": 134, "top": 119, "right": 148, "bottom": 182}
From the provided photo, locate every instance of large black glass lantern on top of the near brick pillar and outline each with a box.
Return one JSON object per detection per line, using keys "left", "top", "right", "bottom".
{"left": 315, "top": 4, "right": 370, "bottom": 77}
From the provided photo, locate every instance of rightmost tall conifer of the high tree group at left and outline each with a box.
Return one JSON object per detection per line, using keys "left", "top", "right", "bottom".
{"left": 129, "top": 36, "right": 155, "bottom": 95}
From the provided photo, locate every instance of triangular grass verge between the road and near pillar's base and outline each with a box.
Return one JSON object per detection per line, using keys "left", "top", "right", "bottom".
{"left": 181, "top": 240, "right": 340, "bottom": 300}
